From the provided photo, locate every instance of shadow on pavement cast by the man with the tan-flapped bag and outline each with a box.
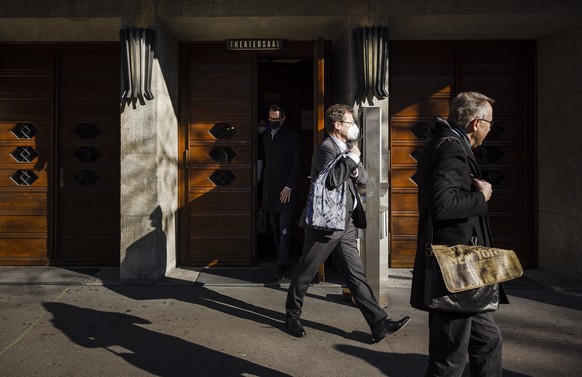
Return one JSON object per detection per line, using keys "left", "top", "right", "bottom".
{"left": 335, "top": 344, "right": 531, "bottom": 377}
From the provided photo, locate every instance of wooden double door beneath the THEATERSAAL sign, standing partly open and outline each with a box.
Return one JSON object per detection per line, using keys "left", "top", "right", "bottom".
{"left": 179, "top": 41, "right": 329, "bottom": 266}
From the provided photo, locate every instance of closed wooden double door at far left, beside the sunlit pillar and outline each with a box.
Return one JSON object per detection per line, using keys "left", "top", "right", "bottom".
{"left": 0, "top": 43, "right": 120, "bottom": 265}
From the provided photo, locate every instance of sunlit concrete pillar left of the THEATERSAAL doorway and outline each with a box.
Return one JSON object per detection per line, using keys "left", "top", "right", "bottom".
{"left": 120, "top": 20, "right": 178, "bottom": 284}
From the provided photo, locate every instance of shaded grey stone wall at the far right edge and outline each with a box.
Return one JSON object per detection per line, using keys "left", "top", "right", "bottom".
{"left": 538, "top": 27, "right": 582, "bottom": 279}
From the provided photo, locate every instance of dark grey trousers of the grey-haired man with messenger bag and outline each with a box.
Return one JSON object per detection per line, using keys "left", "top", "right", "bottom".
{"left": 425, "top": 311, "right": 502, "bottom": 377}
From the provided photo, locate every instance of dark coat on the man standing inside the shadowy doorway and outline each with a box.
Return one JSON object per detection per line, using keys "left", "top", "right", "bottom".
{"left": 262, "top": 124, "right": 302, "bottom": 213}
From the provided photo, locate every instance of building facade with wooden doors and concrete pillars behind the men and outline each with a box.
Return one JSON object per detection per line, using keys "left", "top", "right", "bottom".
{"left": 0, "top": 0, "right": 582, "bottom": 283}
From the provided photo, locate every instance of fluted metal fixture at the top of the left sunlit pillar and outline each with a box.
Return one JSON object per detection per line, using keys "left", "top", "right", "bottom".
{"left": 119, "top": 28, "right": 156, "bottom": 100}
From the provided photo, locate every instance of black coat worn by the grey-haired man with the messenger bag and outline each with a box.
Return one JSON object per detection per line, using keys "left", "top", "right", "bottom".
{"left": 410, "top": 118, "right": 493, "bottom": 310}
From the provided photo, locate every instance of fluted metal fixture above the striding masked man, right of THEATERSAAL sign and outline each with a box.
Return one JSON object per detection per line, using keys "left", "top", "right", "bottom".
{"left": 354, "top": 26, "right": 388, "bottom": 99}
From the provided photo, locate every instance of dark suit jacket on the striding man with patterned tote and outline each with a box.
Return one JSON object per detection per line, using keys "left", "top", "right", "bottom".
{"left": 300, "top": 137, "right": 368, "bottom": 238}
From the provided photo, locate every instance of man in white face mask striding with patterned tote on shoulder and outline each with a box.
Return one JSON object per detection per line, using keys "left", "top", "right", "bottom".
{"left": 285, "top": 104, "right": 410, "bottom": 342}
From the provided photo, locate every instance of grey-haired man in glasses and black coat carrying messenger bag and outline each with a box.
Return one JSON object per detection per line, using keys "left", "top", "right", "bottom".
{"left": 411, "top": 92, "right": 502, "bottom": 377}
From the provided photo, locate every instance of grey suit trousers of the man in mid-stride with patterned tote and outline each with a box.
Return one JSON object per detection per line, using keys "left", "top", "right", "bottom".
{"left": 285, "top": 221, "right": 386, "bottom": 327}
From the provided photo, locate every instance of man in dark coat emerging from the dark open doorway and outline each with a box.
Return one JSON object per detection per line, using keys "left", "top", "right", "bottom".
{"left": 262, "top": 105, "right": 302, "bottom": 280}
